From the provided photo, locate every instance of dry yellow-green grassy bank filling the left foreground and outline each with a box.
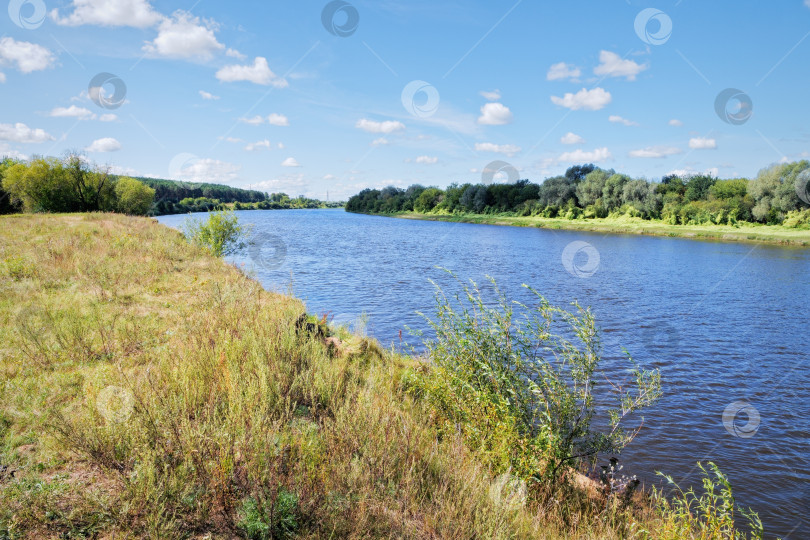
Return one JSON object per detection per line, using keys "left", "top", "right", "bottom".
{"left": 0, "top": 214, "right": 756, "bottom": 538}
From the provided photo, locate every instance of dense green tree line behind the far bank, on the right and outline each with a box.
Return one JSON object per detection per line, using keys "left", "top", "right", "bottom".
{"left": 346, "top": 160, "right": 810, "bottom": 227}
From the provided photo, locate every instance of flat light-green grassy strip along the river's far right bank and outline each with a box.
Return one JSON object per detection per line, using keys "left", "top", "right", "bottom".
{"left": 382, "top": 212, "right": 810, "bottom": 247}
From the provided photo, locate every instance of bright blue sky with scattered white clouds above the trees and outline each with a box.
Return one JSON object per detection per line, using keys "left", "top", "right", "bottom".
{"left": 0, "top": 0, "right": 810, "bottom": 199}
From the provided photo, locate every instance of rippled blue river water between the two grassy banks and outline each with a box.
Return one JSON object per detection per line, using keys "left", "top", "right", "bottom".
{"left": 159, "top": 210, "right": 810, "bottom": 539}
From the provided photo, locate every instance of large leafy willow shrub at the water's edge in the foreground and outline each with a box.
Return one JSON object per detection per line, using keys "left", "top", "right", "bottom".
{"left": 408, "top": 274, "right": 661, "bottom": 482}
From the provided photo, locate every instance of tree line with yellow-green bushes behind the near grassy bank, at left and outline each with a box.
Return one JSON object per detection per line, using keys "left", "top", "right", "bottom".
{"left": 0, "top": 154, "right": 342, "bottom": 216}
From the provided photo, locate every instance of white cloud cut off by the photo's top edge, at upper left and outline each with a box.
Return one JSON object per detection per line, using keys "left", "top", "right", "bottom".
{"left": 51, "top": 0, "right": 162, "bottom": 28}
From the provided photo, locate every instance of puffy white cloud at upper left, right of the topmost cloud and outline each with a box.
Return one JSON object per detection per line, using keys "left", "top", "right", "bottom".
{"left": 143, "top": 10, "right": 225, "bottom": 59}
